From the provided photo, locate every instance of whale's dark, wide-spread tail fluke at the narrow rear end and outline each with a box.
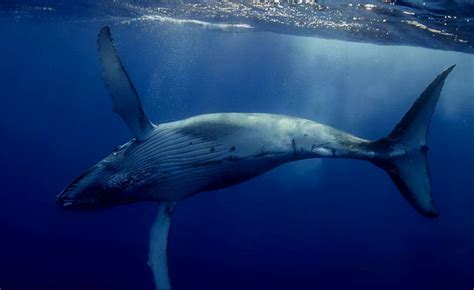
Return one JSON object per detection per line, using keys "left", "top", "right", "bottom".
{"left": 369, "top": 65, "right": 454, "bottom": 218}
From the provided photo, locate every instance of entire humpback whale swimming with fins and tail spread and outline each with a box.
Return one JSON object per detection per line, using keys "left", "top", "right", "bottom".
{"left": 57, "top": 26, "right": 454, "bottom": 290}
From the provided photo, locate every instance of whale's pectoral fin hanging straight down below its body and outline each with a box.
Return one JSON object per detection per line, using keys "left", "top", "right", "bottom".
{"left": 148, "top": 202, "right": 176, "bottom": 290}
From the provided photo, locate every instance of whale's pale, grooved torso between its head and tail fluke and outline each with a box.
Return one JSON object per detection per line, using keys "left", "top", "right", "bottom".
{"left": 111, "top": 113, "right": 374, "bottom": 201}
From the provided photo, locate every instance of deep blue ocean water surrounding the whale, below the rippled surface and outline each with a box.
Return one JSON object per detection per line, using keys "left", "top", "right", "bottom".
{"left": 0, "top": 2, "right": 474, "bottom": 290}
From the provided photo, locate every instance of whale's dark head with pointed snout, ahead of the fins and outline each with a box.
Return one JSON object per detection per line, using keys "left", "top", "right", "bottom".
{"left": 57, "top": 142, "right": 143, "bottom": 210}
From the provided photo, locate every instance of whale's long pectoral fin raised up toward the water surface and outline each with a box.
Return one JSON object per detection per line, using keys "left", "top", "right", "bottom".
{"left": 97, "top": 26, "right": 154, "bottom": 140}
